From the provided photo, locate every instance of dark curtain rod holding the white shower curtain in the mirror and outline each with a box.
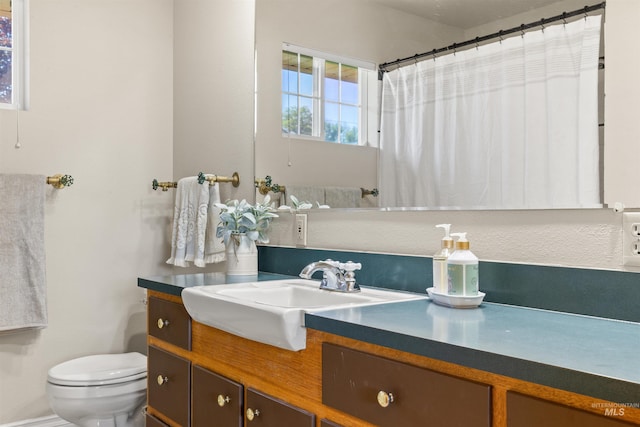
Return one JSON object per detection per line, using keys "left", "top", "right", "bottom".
{"left": 378, "top": 2, "right": 606, "bottom": 78}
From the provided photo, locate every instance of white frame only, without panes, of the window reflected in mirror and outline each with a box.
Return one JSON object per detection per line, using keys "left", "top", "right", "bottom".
{"left": 280, "top": 43, "right": 378, "bottom": 146}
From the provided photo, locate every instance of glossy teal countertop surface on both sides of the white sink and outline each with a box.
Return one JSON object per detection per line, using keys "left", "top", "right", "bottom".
{"left": 138, "top": 273, "right": 640, "bottom": 405}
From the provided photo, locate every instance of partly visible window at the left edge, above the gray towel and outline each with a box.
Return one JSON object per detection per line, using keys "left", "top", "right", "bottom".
{"left": 0, "top": 0, "right": 26, "bottom": 108}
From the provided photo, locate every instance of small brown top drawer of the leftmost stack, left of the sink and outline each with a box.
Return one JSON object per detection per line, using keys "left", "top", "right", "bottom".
{"left": 147, "top": 297, "right": 191, "bottom": 350}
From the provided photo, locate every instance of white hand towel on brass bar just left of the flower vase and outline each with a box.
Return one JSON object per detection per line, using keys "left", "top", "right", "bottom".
{"left": 167, "top": 176, "right": 209, "bottom": 267}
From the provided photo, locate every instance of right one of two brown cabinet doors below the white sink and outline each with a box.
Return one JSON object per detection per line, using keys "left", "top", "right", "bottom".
{"left": 245, "top": 388, "right": 316, "bottom": 427}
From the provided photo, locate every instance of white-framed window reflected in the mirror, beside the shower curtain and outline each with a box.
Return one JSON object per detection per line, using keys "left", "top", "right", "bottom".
{"left": 282, "top": 44, "right": 377, "bottom": 145}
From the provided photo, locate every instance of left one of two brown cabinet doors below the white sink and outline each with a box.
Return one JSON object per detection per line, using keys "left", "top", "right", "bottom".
{"left": 191, "top": 366, "right": 243, "bottom": 427}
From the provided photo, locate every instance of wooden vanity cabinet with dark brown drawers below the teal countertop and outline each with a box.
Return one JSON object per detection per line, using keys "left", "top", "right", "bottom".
{"left": 147, "top": 292, "right": 640, "bottom": 427}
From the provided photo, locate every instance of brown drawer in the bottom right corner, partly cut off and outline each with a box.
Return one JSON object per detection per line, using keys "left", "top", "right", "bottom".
{"left": 507, "top": 391, "right": 635, "bottom": 427}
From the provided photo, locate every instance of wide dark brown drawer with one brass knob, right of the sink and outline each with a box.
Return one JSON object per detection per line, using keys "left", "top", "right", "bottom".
{"left": 322, "top": 343, "right": 491, "bottom": 427}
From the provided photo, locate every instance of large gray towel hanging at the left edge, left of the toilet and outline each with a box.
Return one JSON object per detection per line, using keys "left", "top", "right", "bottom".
{"left": 0, "top": 174, "right": 47, "bottom": 332}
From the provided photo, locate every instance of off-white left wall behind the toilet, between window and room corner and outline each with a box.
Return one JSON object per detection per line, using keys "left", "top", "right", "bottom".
{"left": 0, "top": 0, "right": 173, "bottom": 424}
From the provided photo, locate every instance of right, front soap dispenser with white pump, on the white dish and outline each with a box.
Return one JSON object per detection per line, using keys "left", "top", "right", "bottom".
{"left": 447, "top": 233, "right": 478, "bottom": 296}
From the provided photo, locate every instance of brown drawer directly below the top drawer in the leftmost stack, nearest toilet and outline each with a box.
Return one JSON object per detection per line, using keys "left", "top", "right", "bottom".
{"left": 147, "top": 346, "right": 190, "bottom": 427}
